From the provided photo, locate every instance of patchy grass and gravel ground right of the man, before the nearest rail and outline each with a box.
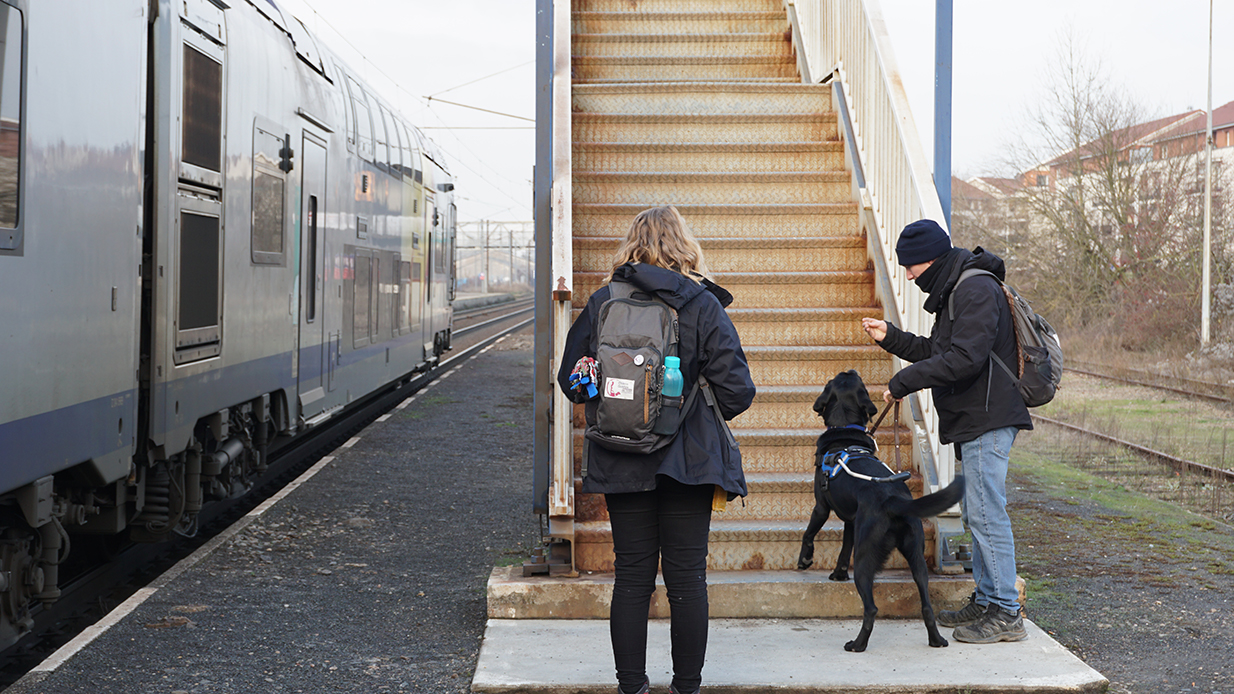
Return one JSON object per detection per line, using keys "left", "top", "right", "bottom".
{"left": 1007, "top": 431, "right": 1234, "bottom": 694}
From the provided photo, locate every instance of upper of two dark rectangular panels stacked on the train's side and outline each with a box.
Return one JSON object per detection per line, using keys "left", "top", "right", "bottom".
{"left": 181, "top": 44, "right": 223, "bottom": 172}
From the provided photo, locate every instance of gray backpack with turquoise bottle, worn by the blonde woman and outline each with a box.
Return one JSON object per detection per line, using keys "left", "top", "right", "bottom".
{"left": 585, "top": 280, "right": 701, "bottom": 453}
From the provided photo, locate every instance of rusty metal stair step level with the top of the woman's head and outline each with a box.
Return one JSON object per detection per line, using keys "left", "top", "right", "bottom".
{"left": 573, "top": 203, "right": 864, "bottom": 238}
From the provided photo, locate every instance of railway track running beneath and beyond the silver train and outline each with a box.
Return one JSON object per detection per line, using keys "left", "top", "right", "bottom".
{"left": 0, "top": 301, "right": 532, "bottom": 689}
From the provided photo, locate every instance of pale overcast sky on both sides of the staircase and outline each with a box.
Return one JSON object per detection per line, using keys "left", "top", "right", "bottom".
{"left": 278, "top": 0, "right": 1234, "bottom": 221}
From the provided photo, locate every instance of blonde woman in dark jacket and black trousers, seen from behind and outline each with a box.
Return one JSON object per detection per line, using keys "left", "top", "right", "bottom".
{"left": 558, "top": 206, "right": 754, "bottom": 694}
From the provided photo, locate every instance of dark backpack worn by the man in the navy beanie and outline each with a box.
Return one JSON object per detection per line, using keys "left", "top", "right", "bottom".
{"left": 946, "top": 268, "right": 1062, "bottom": 408}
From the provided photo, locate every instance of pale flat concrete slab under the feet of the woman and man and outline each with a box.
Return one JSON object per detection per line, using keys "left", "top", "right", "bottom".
{"left": 471, "top": 619, "right": 1109, "bottom": 694}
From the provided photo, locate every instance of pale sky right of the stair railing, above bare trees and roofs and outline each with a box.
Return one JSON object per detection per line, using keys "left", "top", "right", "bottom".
{"left": 879, "top": 0, "right": 1234, "bottom": 178}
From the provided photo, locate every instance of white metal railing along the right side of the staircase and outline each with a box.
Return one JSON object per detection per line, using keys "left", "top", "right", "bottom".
{"left": 785, "top": 0, "right": 955, "bottom": 487}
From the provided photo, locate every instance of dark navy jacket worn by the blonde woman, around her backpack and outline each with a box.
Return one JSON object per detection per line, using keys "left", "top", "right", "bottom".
{"left": 557, "top": 263, "right": 754, "bottom": 496}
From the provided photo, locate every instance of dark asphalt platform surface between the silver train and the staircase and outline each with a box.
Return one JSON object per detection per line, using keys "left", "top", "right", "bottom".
{"left": 5, "top": 332, "right": 539, "bottom": 694}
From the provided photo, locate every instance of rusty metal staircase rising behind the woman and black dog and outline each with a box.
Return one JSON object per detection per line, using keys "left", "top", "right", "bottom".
{"left": 571, "top": 0, "right": 932, "bottom": 582}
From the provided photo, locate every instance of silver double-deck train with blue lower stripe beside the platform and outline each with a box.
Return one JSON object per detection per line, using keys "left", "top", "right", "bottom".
{"left": 0, "top": 0, "right": 455, "bottom": 645}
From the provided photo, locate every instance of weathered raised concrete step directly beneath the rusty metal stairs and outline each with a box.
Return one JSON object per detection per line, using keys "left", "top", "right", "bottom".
{"left": 489, "top": 567, "right": 972, "bottom": 620}
